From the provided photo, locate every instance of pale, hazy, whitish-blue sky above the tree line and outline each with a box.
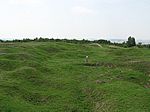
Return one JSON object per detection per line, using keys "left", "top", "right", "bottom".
{"left": 0, "top": 0, "right": 150, "bottom": 40}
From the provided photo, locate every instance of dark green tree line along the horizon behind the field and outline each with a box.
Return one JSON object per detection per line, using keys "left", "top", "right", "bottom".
{"left": 0, "top": 36, "right": 150, "bottom": 48}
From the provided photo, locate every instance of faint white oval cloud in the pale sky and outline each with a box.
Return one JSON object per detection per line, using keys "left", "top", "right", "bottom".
{"left": 72, "top": 6, "right": 93, "bottom": 15}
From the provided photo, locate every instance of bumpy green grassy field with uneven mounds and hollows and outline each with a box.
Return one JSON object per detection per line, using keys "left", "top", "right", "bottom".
{"left": 0, "top": 42, "right": 150, "bottom": 112}
